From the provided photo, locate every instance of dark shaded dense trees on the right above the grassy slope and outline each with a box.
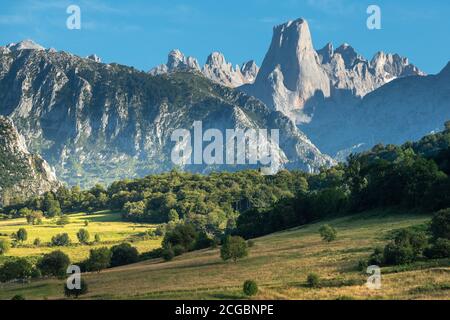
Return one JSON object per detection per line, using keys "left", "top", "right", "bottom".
{"left": 233, "top": 128, "right": 450, "bottom": 243}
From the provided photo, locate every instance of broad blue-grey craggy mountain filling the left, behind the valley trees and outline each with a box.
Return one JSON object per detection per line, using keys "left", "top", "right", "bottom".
{"left": 0, "top": 42, "right": 333, "bottom": 186}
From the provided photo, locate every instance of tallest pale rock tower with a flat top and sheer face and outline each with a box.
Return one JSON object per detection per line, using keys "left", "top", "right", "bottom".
{"left": 242, "top": 19, "right": 330, "bottom": 122}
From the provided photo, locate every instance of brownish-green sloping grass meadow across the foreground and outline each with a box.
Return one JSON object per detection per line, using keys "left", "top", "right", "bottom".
{"left": 0, "top": 212, "right": 450, "bottom": 299}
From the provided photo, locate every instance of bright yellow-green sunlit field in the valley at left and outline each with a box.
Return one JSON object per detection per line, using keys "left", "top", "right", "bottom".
{"left": 0, "top": 211, "right": 161, "bottom": 262}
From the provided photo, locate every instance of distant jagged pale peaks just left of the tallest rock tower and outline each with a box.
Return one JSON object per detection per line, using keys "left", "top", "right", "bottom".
{"left": 149, "top": 50, "right": 259, "bottom": 88}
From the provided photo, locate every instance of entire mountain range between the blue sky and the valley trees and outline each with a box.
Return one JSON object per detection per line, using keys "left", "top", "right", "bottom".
{"left": 0, "top": 19, "right": 450, "bottom": 186}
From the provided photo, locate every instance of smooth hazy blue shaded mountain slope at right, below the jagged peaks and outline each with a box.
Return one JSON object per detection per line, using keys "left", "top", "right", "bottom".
{"left": 301, "top": 63, "right": 450, "bottom": 160}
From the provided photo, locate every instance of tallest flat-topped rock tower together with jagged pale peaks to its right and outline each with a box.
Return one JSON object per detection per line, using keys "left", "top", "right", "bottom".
{"left": 241, "top": 19, "right": 424, "bottom": 124}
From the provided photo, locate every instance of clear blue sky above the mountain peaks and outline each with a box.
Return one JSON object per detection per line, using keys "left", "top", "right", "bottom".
{"left": 0, "top": 0, "right": 450, "bottom": 73}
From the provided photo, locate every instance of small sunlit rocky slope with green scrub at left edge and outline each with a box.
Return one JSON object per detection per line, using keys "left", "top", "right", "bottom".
{"left": 0, "top": 116, "right": 61, "bottom": 206}
